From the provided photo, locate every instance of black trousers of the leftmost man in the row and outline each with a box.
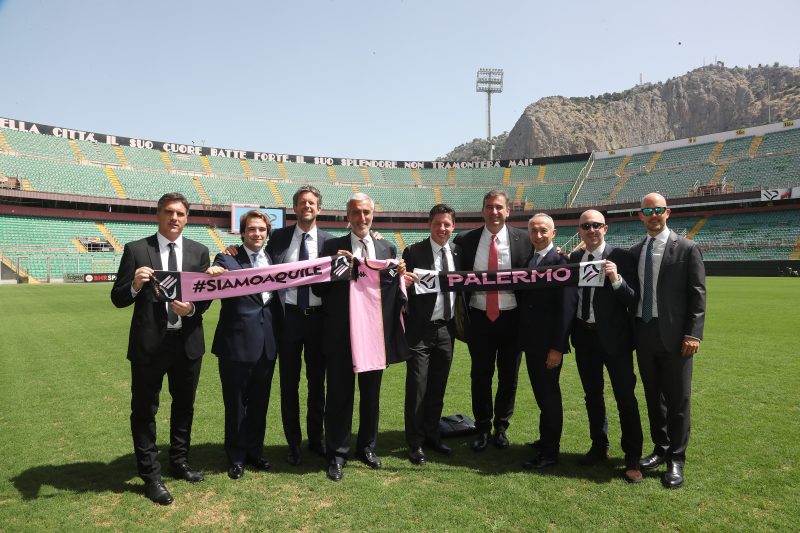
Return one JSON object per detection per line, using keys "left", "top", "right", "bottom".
{"left": 131, "top": 333, "right": 202, "bottom": 483}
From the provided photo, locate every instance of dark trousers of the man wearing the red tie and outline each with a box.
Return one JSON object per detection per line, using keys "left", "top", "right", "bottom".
{"left": 467, "top": 308, "right": 522, "bottom": 433}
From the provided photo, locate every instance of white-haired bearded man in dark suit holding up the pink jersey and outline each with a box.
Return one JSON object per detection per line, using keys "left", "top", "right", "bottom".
{"left": 313, "top": 193, "right": 404, "bottom": 481}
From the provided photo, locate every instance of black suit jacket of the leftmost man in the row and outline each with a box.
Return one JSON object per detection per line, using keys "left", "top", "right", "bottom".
{"left": 111, "top": 235, "right": 211, "bottom": 361}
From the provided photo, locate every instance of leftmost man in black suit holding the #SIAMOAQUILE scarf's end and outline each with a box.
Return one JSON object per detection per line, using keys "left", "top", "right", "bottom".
{"left": 111, "top": 193, "right": 214, "bottom": 505}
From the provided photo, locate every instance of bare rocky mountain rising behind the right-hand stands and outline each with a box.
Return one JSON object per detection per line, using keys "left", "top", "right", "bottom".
{"left": 500, "top": 64, "right": 800, "bottom": 159}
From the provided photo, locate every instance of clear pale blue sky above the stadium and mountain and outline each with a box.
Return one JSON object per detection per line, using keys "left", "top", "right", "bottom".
{"left": 0, "top": 0, "right": 800, "bottom": 160}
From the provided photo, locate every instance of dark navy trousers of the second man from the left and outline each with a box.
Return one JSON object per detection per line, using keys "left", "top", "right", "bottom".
{"left": 219, "top": 355, "right": 275, "bottom": 464}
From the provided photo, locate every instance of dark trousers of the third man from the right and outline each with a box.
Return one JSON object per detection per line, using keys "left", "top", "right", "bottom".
{"left": 525, "top": 350, "right": 564, "bottom": 458}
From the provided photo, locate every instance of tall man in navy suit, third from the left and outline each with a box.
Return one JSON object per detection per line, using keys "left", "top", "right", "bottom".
{"left": 267, "top": 185, "right": 333, "bottom": 466}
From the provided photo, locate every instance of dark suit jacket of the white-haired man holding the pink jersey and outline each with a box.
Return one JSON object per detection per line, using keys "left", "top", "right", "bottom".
{"left": 312, "top": 233, "right": 397, "bottom": 353}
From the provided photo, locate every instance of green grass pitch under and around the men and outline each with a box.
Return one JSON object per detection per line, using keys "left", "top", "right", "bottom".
{"left": 0, "top": 278, "right": 800, "bottom": 531}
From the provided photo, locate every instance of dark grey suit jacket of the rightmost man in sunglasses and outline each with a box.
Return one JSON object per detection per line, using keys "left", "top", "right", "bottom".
{"left": 631, "top": 231, "right": 706, "bottom": 351}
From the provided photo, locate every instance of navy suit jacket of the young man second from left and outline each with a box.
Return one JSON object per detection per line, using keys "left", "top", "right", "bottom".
{"left": 211, "top": 246, "right": 280, "bottom": 363}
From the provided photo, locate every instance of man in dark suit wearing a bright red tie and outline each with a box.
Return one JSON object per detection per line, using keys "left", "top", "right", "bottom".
{"left": 453, "top": 190, "right": 531, "bottom": 452}
